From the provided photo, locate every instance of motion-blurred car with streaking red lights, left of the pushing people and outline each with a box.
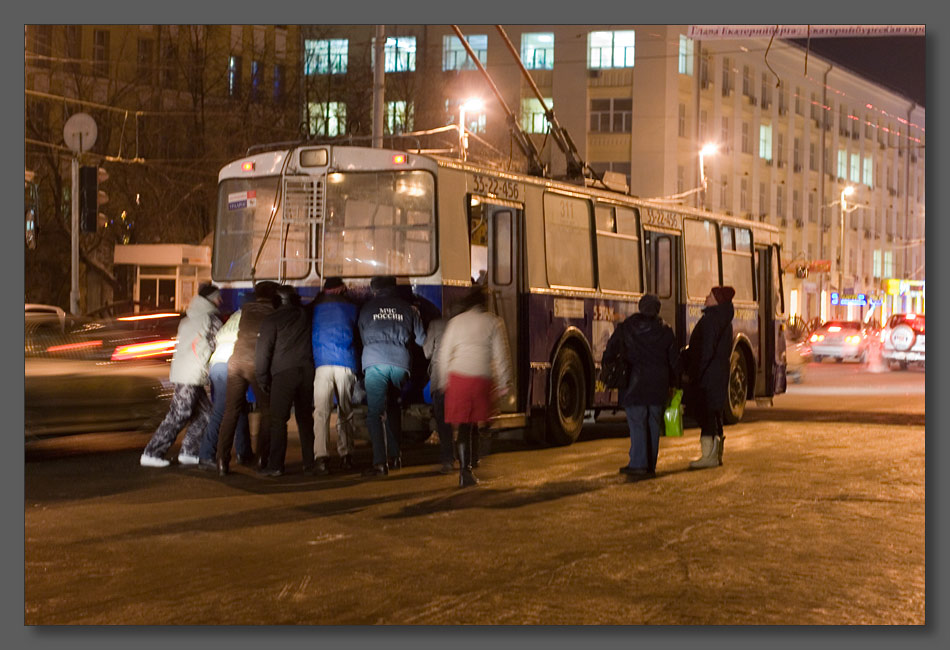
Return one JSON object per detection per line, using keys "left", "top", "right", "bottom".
{"left": 24, "top": 312, "right": 180, "bottom": 438}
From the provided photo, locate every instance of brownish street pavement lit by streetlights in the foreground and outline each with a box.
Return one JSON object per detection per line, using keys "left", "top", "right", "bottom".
{"left": 24, "top": 362, "right": 925, "bottom": 625}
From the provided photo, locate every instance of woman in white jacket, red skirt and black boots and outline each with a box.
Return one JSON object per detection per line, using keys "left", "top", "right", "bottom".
{"left": 433, "top": 286, "right": 511, "bottom": 487}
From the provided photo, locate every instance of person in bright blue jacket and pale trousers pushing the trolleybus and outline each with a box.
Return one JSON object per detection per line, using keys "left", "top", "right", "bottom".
{"left": 312, "top": 277, "right": 359, "bottom": 476}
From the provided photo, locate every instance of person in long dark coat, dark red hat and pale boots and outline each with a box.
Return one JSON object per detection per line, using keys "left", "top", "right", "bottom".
{"left": 686, "top": 287, "right": 736, "bottom": 469}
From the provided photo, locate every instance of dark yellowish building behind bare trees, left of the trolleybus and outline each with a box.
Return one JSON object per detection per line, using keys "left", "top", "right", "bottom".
{"left": 25, "top": 25, "right": 301, "bottom": 313}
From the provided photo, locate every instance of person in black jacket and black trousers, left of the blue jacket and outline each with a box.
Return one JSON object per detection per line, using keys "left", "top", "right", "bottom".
{"left": 256, "top": 285, "right": 313, "bottom": 476}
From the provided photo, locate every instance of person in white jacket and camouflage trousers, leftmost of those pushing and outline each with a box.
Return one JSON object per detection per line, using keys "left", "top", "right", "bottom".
{"left": 139, "top": 284, "right": 221, "bottom": 467}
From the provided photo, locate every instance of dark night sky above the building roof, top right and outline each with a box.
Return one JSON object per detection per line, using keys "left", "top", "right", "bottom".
{"left": 793, "top": 36, "right": 927, "bottom": 106}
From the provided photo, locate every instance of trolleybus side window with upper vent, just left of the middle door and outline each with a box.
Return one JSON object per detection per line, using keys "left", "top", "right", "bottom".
{"left": 594, "top": 205, "right": 642, "bottom": 292}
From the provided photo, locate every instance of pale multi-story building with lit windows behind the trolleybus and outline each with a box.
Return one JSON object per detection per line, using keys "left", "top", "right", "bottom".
{"left": 301, "top": 25, "right": 926, "bottom": 318}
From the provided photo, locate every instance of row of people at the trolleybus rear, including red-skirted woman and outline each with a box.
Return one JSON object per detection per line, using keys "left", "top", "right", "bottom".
{"left": 139, "top": 276, "right": 511, "bottom": 487}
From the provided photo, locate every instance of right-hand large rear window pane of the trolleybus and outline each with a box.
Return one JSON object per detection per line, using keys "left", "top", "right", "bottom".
{"left": 323, "top": 171, "right": 436, "bottom": 277}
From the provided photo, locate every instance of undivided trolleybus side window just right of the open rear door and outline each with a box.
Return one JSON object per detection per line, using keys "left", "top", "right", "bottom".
{"left": 544, "top": 192, "right": 594, "bottom": 289}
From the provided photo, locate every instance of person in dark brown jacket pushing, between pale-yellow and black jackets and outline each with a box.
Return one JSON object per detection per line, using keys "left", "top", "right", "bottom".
{"left": 216, "top": 280, "right": 280, "bottom": 476}
